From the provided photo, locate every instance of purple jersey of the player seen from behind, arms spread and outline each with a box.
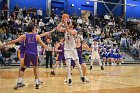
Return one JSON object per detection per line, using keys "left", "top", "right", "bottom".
{"left": 25, "top": 34, "right": 38, "bottom": 55}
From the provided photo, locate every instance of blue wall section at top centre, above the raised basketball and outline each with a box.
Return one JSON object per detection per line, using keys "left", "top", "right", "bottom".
{"left": 52, "top": 0, "right": 94, "bottom": 16}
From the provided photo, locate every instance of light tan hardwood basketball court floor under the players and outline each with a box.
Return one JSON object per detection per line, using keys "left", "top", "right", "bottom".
{"left": 0, "top": 65, "right": 140, "bottom": 93}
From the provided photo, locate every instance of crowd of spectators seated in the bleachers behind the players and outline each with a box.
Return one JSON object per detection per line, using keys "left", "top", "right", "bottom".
{"left": 0, "top": 5, "right": 140, "bottom": 66}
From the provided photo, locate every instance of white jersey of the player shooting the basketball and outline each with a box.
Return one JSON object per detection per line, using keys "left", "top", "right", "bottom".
{"left": 64, "top": 32, "right": 76, "bottom": 50}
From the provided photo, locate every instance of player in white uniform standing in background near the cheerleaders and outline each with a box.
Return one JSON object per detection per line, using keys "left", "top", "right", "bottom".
{"left": 90, "top": 40, "right": 104, "bottom": 70}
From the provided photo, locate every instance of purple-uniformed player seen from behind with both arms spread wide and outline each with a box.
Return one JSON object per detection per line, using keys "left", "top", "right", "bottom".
{"left": 2, "top": 24, "right": 47, "bottom": 89}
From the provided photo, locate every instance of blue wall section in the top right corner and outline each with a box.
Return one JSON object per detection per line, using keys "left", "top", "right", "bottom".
{"left": 126, "top": 0, "right": 140, "bottom": 18}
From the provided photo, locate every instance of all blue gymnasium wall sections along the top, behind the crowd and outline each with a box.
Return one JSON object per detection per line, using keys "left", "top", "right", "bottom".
{"left": 6, "top": 0, "right": 140, "bottom": 18}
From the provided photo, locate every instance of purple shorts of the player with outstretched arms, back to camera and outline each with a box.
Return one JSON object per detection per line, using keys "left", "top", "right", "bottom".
{"left": 24, "top": 54, "right": 38, "bottom": 67}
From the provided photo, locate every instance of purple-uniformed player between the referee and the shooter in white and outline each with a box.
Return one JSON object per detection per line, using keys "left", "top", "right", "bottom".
{"left": 51, "top": 37, "right": 66, "bottom": 75}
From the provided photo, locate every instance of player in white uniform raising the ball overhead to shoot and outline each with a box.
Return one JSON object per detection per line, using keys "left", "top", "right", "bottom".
{"left": 57, "top": 15, "right": 85, "bottom": 85}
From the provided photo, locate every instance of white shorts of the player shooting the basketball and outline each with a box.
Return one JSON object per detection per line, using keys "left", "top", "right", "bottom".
{"left": 64, "top": 49, "right": 79, "bottom": 60}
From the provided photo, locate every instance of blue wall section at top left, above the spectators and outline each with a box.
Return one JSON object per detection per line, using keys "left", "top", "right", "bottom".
{"left": 10, "top": 0, "right": 47, "bottom": 11}
